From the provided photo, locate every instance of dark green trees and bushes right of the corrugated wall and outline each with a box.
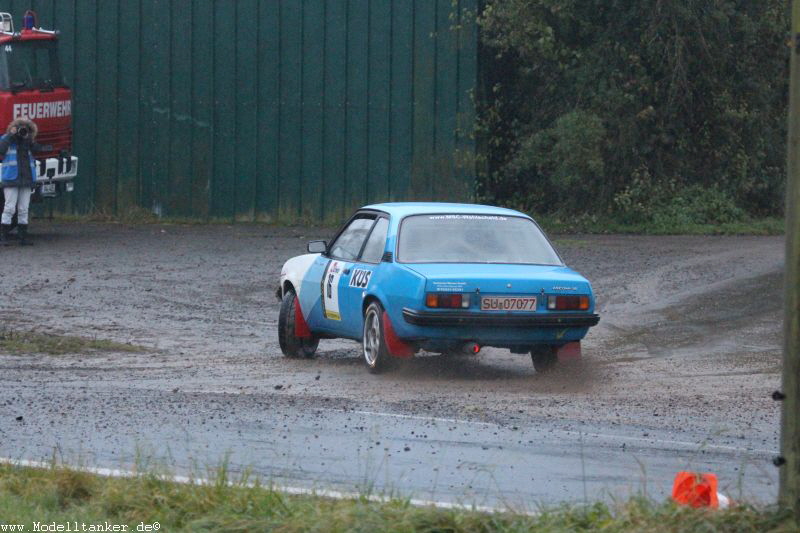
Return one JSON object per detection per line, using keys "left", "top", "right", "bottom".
{"left": 477, "top": 0, "right": 789, "bottom": 223}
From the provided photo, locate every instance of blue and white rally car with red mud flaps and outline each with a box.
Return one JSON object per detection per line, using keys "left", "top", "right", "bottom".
{"left": 278, "top": 203, "right": 598, "bottom": 372}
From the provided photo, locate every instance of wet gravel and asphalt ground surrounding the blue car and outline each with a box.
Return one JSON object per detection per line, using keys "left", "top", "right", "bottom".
{"left": 0, "top": 222, "right": 783, "bottom": 508}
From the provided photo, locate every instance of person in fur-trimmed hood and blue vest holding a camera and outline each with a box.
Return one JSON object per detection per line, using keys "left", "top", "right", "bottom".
{"left": 0, "top": 118, "right": 48, "bottom": 246}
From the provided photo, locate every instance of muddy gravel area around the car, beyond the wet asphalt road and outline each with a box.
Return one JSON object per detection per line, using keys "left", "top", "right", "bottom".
{"left": 0, "top": 222, "right": 783, "bottom": 456}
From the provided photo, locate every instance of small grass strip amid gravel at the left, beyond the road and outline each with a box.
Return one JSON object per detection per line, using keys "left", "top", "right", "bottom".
{"left": 0, "top": 331, "right": 144, "bottom": 355}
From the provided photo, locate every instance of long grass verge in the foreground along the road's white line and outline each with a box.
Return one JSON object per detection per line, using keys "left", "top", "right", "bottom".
{"left": 0, "top": 465, "right": 798, "bottom": 532}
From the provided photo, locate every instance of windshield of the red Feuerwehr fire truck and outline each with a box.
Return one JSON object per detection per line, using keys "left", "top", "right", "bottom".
{"left": 0, "top": 41, "right": 64, "bottom": 91}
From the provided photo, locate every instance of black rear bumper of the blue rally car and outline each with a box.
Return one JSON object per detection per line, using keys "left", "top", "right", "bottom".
{"left": 403, "top": 307, "right": 600, "bottom": 328}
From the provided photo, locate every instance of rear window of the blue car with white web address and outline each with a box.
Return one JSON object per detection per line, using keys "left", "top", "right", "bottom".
{"left": 398, "top": 214, "right": 563, "bottom": 265}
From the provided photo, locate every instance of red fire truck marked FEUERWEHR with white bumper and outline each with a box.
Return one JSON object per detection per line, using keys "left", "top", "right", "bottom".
{"left": 0, "top": 11, "right": 78, "bottom": 204}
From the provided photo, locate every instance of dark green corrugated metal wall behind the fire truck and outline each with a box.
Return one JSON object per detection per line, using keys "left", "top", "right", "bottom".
{"left": 0, "top": 0, "right": 477, "bottom": 221}
